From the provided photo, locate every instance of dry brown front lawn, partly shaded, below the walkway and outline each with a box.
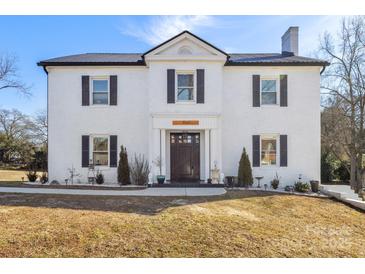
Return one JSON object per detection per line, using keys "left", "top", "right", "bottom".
{"left": 0, "top": 191, "right": 365, "bottom": 257}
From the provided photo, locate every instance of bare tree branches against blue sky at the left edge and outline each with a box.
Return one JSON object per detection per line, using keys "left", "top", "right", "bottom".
{"left": 0, "top": 55, "right": 30, "bottom": 95}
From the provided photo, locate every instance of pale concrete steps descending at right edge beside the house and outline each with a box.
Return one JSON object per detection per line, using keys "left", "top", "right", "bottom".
{"left": 321, "top": 185, "right": 365, "bottom": 210}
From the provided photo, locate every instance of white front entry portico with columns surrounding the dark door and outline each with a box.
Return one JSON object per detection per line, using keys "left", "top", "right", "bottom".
{"left": 149, "top": 113, "right": 222, "bottom": 183}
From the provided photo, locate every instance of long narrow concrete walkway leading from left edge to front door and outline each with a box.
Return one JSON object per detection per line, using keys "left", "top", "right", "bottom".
{"left": 0, "top": 187, "right": 226, "bottom": 196}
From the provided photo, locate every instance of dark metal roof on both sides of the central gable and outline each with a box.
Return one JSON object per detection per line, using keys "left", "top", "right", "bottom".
{"left": 38, "top": 53, "right": 329, "bottom": 67}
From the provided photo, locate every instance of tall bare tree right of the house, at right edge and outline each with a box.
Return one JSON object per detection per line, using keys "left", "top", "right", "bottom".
{"left": 320, "top": 16, "right": 365, "bottom": 192}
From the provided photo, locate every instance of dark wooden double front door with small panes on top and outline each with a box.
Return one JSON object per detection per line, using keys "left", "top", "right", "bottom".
{"left": 170, "top": 133, "right": 200, "bottom": 181}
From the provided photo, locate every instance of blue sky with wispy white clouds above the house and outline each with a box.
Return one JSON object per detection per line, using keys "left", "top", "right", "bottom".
{"left": 0, "top": 16, "right": 341, "bottom": 114}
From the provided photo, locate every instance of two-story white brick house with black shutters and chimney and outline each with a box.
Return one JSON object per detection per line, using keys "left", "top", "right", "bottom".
{"left": 39, "top": 27, "right": 327, "bottom": 185}
